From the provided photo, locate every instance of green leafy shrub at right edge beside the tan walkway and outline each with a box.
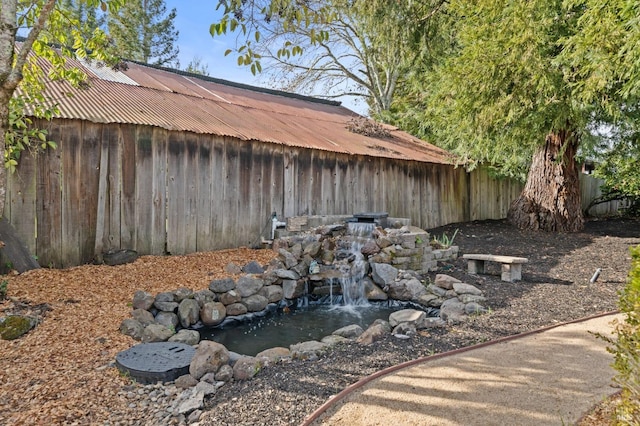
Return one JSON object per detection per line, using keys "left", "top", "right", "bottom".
{"left": 608, "top": 246, "right": 640, "bottom": 425}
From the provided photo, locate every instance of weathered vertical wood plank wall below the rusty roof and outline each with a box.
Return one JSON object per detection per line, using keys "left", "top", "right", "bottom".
{"left": 0, "top": 120, "right": 616, "bottom": 267}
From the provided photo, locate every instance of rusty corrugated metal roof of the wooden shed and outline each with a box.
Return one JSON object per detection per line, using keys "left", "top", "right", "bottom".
{"left": 32, "top": 56, "right": 450, "bottom": 163}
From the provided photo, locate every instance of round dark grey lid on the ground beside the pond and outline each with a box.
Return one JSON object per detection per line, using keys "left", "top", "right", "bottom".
{"left": 116, "top": 342, "right": 196, "bottom": 384}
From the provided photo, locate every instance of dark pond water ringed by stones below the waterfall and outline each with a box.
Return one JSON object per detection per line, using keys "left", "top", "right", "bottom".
{"left": 198, "top": 296, "right": 439, "bottom": 356}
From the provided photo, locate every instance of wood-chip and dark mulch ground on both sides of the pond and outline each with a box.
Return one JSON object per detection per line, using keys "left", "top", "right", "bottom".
{"left": 0, "top": 219, "right": 640, "bottom": 425}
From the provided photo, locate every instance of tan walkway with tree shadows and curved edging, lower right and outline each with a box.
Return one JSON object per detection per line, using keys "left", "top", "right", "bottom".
{"left": 304, "top": 314, "right": 623, "bottom": 426}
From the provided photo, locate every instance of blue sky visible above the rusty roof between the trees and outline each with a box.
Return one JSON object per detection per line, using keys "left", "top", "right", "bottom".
{"left": 165, "top": 0, "right": 366, "bottom": 115}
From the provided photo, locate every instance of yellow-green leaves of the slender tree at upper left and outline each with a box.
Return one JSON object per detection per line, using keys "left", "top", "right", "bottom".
{"left": 0, "top": 0, "right": 122, "bottom": 173}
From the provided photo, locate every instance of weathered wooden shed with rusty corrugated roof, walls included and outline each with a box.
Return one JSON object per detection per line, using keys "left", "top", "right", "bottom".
{"left": 5, "top": 63, "right": 521, "bottom": 267}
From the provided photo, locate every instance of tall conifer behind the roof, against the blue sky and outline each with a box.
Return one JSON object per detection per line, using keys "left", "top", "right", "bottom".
{"left": 107, "top": 0, "right": 179, "bottom": 66}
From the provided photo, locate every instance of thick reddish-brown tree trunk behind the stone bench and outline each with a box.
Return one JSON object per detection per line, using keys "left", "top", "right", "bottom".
{"left": 507, "top": 130, "right": 584, "bottom": 232}
